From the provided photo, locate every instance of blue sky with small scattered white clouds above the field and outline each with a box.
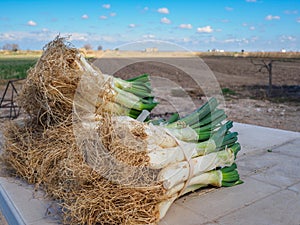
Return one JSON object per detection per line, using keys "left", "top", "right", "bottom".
{"left": 0, "top": 0, "right": 300, "bottom": 51}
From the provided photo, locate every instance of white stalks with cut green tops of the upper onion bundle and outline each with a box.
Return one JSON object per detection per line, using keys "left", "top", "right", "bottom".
{"left": 76, "top": 54, "right": 157, "bottom": 118}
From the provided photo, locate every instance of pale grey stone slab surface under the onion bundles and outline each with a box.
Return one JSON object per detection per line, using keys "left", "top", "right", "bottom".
{"left": 0, "top": 123, "right": 300, "bottom": 225}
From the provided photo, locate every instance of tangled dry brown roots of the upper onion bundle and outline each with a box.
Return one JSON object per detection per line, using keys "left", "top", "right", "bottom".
{"left": 19, "top": 36, "right": 101, "bottom": 126}
